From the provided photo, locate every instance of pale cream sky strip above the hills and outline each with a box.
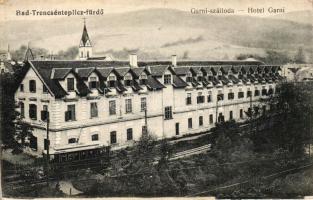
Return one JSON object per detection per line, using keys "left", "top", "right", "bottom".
{"left": 0, "top": 0, "right": 313, "bottom": 21}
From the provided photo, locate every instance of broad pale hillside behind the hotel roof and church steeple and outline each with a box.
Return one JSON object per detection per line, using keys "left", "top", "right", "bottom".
{"left": 0, "top": 9, "right": 313, "bottom": 59}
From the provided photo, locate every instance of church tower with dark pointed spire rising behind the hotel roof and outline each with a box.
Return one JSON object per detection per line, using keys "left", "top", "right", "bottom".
{"left": 78, "top": 18, "right": 92, "bottom": 60}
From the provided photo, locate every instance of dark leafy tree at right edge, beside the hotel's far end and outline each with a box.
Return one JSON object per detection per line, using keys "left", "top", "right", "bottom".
{"left": 260, "top": 83, "right": 313, "bottom": 154}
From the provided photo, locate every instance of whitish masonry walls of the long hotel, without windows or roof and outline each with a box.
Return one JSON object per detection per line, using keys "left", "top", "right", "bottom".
{"left": 15, "top": 68, "right": 275, "bottom": 155}
